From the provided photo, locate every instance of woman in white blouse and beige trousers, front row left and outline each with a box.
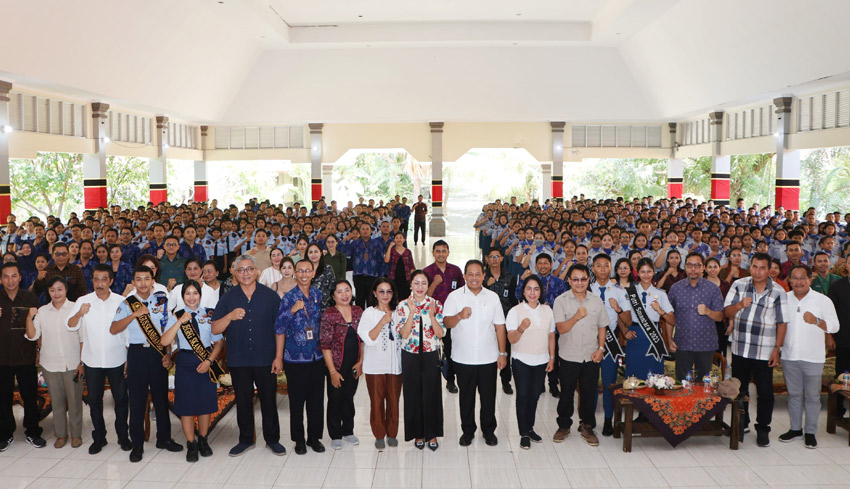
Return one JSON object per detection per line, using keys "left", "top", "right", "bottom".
{"left": 26, "top": 277, "right": 83, "bottom": 448}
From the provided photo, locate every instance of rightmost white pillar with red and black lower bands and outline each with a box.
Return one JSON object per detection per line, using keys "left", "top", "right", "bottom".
{"left": 773, "top": 97, "right": 800, "bottom": 211}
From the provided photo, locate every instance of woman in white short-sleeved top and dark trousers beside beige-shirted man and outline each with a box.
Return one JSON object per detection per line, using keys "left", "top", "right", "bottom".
{"left": 505, "top": 275, "right": 555, "bottom": 450}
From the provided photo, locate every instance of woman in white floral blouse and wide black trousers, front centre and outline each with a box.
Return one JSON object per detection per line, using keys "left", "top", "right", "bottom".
{"left": 393, "top": 270, "right": 446, "bottom": 451}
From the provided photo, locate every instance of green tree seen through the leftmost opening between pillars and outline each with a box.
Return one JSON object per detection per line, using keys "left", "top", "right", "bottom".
{"left": 9, "top": 153, "right": 83, "bottom": 220}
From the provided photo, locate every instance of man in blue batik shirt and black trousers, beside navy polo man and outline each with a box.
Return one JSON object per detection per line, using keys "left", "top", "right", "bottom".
{"left": 275, "top": 260, "right": 325, "bottom": 455}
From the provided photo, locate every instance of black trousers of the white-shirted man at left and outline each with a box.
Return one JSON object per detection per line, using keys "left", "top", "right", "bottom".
{"left": 85, "top": 364, "right": 130, "bottom": 441}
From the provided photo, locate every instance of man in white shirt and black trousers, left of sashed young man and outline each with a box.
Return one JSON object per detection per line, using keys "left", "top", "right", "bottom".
{"left": 68, "top": 265, "right": 133, "bottom": 455}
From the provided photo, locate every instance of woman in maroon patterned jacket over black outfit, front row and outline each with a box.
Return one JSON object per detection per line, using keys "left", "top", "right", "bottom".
{"left": 308, "top": 278, "right": 363, "bottom": 450}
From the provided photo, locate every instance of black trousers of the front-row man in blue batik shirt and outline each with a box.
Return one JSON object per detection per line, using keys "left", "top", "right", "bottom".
{"left": 283, "top": 360, "right": 327, "bottom": 443}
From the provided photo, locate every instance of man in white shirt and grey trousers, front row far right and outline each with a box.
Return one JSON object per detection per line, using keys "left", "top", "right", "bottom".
{"left": 779, "top": 265, "right": 838, "bottom": 448}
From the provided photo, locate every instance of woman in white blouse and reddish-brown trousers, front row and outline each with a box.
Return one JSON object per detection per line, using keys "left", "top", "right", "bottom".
{"left": 357, "top": 278, "right": 401, "bottom": 450}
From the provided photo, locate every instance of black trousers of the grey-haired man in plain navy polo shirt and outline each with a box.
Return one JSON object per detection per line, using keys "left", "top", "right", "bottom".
{"left": 230, "top": 366, "right": 280, "bottom": 445}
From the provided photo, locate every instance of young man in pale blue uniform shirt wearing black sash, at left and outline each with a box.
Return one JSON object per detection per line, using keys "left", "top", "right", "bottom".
{"left": 109, "top": 266, "right": 183, "bottom": 462}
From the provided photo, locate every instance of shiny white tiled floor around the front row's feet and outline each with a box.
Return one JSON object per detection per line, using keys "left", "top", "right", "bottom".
{"left": 0, "top": 234, "right": 850, "bottom": 489}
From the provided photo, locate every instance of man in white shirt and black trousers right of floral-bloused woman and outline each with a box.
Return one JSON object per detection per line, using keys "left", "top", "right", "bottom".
{"left": 443, "top": 260, "right": 507, "bottom": 447}
